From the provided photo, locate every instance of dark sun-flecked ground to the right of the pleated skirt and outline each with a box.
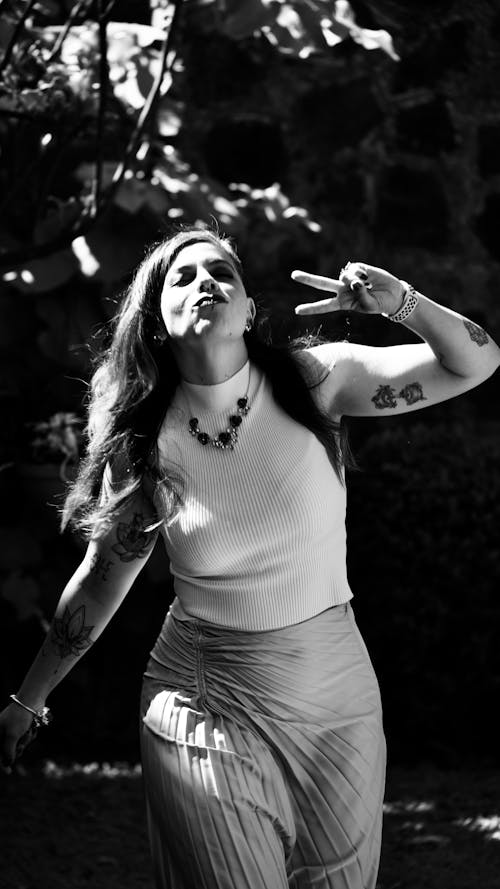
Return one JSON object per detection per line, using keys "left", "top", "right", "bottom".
{"left": 377, "top": 764, "right": 500, "bottom": 889}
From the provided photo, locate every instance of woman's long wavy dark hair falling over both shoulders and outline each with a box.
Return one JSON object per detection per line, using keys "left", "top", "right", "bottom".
{"left": 61, "top": 226, "right": 354, "bottom": 538}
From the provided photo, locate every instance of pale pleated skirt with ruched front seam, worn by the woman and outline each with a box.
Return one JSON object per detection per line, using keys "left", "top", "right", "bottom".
{"left": 141, "top": 604, "right": 386, "bottom": 889}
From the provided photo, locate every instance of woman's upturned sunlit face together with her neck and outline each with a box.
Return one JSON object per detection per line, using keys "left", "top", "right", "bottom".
{"left": 160, "top": 243, "right": 255, "bottom": 385}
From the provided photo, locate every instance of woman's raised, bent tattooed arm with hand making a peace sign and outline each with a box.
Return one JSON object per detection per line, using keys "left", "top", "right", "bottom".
{"left": 293, "top": 263, "right": 500, "bottom": 417}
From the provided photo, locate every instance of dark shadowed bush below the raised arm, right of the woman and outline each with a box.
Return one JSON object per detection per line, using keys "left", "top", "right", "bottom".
{"left": 348, "top": 419, "right": 500, "bottom": 762}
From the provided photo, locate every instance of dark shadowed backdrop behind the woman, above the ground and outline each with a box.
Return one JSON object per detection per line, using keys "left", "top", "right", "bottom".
{"left": 0, "top": 0, "right": 500, "bottom": 766}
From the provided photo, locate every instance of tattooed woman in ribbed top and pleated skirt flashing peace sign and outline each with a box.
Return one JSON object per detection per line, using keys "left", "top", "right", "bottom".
{"left": 0, "top": 228, "right": 500, "bottom": 889}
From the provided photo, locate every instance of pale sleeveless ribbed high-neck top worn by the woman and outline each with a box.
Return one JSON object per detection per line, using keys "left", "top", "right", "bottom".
{"left": 158, "top": 362, "right": 352, "bottom": 630}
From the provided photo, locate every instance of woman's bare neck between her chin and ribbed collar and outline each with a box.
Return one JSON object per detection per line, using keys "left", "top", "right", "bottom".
{"left": 172, "top": 339, "right": 248, "bottom": 386}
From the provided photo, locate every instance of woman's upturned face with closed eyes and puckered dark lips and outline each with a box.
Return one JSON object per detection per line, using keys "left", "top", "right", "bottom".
{"left": 160, "top": 241, "right": 255, "bottom": 345}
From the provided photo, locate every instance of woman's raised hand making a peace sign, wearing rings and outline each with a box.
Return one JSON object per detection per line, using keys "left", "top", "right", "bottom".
{"left": 292, "top": 262, "right": 405, "bottom": 315}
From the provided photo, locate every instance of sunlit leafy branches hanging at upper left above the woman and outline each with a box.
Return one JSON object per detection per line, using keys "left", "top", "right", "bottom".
{"left": 0, "top": 0, "right": 397, "bottom": 278}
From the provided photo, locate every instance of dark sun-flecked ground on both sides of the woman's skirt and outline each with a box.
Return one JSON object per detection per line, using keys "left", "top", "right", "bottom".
{"left": 0, "top": 762, "right": 500, "bottom": 889}
